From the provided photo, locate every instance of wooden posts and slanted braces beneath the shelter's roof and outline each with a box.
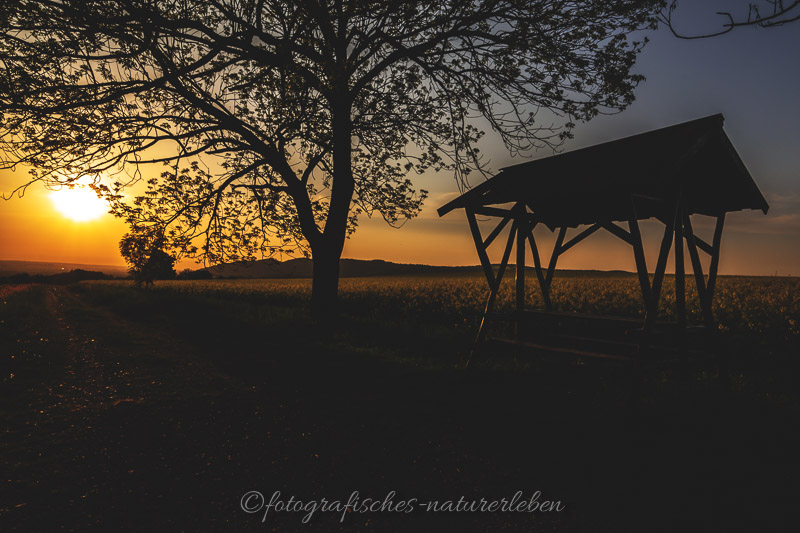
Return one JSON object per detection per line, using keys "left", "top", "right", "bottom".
{"left": 464, "top": 196, "right": 725, "bottom": 372}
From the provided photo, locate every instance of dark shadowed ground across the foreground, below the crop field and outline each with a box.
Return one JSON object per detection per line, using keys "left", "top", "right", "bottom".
{"left": 0, "top": 286, "right": 800, "bottom": 532}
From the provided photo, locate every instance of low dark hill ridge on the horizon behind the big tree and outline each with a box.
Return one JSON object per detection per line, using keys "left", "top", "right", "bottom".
{"left": 197, "top": 258, "right": 632, "bottom": 279}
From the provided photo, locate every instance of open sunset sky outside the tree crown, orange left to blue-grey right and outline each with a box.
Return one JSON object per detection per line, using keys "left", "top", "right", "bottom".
{"left": 0, "top": 2, "right": 800, "bottom": 275}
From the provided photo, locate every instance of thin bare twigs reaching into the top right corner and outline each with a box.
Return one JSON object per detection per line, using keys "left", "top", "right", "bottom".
{"left": 660, "top": 0, "right": 800, "bottom": 39}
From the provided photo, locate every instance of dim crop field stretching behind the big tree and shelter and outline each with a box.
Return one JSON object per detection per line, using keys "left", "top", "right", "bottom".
{"left": 80, "top": 274, "right": 800, "bottom": 354}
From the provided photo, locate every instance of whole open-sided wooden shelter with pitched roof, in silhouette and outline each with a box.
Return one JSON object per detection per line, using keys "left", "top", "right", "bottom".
{"left": 438, "top": 114, "right": 769, "bottom": 368}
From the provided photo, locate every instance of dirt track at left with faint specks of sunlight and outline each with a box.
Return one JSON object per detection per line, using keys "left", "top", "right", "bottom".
{"left": 0, "top": 287, "right": 255, "bottom": 531}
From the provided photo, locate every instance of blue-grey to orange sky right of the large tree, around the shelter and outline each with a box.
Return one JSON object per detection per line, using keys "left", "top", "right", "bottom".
{"left": 345, "top": 1, "right": 800, "bottom": 275}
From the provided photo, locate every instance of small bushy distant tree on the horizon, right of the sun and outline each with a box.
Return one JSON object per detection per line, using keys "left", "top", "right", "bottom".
{"left": 119, "top": 232, "right": 177, "bottom": 287}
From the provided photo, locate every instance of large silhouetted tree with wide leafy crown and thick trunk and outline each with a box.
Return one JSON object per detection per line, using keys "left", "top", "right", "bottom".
{"left": 0, "top": 0, "right": 664, "bottom": 315}
